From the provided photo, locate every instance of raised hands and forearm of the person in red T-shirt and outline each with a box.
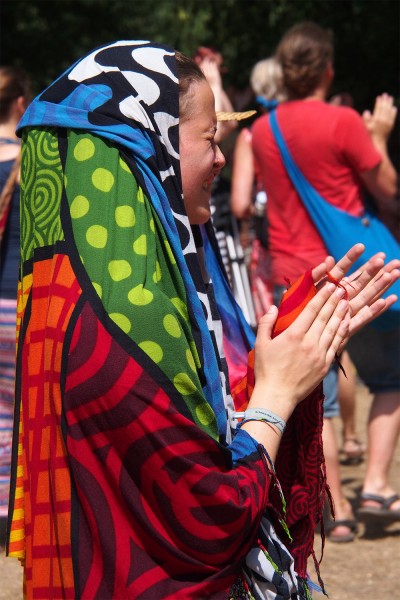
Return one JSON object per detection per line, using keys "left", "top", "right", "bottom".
{"left": 361, "top": 94, "right": 397, "bottom": 208}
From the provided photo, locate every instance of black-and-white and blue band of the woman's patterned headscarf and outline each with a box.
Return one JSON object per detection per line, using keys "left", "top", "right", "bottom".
{"left": 20, "top": 41, "right": 253, "bottom": 435}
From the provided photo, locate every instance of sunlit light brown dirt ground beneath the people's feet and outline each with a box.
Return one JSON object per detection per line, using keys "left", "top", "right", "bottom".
{"left": 0, "top": 386, "right": 400, "bottom": 600}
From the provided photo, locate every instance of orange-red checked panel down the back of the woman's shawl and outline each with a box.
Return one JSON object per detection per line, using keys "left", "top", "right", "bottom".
{"left": 9, "top": 255, "right": 81, "bottom": 598}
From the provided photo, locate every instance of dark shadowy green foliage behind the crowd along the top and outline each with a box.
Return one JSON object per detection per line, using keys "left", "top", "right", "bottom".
{"left": 0, "top": 0, "right": 400, "bottom": 110}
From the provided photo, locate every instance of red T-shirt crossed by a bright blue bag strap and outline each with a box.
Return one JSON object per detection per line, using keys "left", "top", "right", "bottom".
{"left": 253, "top": 98, "right": 380, "bottom": 285}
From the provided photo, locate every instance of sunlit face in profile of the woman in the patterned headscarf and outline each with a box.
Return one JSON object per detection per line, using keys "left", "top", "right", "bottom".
{"left": 179, "top": 81, "right": 225, "bottom": 225}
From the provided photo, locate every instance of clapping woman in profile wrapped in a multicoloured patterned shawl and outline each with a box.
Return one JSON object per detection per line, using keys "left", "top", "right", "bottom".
{"left": 8, "top": 41, "right": 400, "bottom": 600}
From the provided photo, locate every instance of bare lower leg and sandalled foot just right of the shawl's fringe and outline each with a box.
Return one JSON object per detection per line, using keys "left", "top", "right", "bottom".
{"left": 322, "top": 418, "right": 354, "bottom": 541}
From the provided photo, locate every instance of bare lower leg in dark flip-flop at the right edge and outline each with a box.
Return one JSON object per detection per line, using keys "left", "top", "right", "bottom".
{"left": 362, "top": 392, "right": 400, "bottom": 510}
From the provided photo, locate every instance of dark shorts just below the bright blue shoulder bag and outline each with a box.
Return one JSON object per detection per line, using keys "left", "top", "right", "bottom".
{"left": 346, "top": 315, "right": 400, "bottom": 394}
